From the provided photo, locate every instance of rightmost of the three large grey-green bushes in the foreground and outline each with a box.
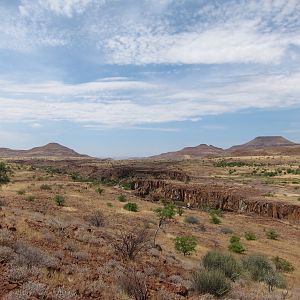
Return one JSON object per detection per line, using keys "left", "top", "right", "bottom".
{"left": 242, "top": 255, "right": 273, "bottom": 281}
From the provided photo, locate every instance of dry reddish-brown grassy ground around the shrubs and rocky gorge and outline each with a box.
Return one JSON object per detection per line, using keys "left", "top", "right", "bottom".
{"left": 0, "top": 157, "right": 300, "bottom": 299}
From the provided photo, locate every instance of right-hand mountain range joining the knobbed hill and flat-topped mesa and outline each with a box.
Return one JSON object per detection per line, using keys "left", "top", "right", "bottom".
{"left": 150, "top": 136, "right": 300, "bottom": 159}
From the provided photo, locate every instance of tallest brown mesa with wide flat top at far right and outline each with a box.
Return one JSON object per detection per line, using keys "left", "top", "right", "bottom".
{"left": 227, "top": 136, "right": 298, "bottom": 151}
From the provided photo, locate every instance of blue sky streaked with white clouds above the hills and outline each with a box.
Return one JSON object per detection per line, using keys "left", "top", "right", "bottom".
{"left": 0, "top": 0, "right": 300, "bottom": 157}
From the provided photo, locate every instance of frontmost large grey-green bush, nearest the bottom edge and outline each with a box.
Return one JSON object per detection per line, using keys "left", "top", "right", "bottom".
{"left": 192, "top": 269, "right": 231, "bottom": 297}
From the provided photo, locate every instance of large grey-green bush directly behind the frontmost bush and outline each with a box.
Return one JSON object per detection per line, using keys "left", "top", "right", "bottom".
{"left": 202, "top": 251, "right": 242, "bottom": 280}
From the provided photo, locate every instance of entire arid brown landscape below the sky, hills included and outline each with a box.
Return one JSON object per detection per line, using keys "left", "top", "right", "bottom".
{"left": 0, "top": 137, "right": 300, "bottom": 300}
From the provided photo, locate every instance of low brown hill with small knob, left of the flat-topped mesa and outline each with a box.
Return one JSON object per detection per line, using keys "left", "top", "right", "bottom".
{"left": 151, "top": 144, "right": 224, "bottom": 159}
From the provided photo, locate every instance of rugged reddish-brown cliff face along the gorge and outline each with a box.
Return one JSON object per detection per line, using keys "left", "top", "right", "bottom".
{"left": 134, "top": 180, "right": 300, "bottom": 222}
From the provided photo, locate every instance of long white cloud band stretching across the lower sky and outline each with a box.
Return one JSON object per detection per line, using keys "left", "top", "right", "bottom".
{"left": 0, "top": 72, "right": 300, "bottom": 128}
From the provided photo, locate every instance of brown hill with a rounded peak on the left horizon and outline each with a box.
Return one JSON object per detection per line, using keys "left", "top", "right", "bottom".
{"left": 0, "top": 143, "right": 86, "bottom": 158}
